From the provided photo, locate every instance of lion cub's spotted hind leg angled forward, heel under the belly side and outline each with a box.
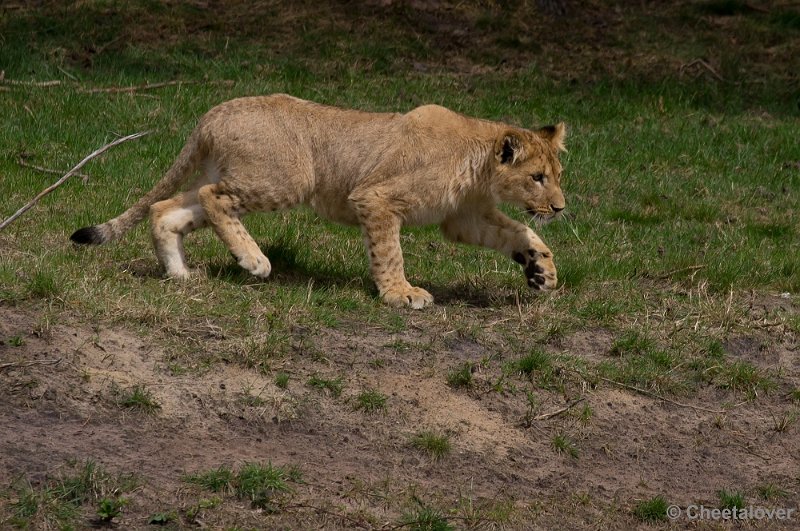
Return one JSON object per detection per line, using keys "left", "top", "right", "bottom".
{"left": 198, "top": 184, "right": 275, "bottom": 278}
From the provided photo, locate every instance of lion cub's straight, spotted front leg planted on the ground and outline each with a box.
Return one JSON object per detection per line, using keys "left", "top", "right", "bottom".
{"left": 353, "top": 193, "right": 433, "bottom": 309}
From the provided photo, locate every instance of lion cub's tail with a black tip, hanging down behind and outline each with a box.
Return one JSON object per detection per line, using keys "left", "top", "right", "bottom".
{"left": 69, "top": 129, "right": 206, "bottom": 245}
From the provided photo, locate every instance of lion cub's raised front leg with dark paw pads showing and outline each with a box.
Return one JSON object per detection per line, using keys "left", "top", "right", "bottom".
{"left": 442, "top": 209, "right": 558, "bottom": 290}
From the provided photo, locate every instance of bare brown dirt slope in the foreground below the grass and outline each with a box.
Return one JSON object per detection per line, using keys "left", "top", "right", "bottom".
{"left": 0, "top": 307, "right": 800, "bottom": 529}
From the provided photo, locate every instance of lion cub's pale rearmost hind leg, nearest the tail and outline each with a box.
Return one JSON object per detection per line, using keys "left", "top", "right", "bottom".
{"left": 150, "top": 191, "right": 207, "bottom": 278}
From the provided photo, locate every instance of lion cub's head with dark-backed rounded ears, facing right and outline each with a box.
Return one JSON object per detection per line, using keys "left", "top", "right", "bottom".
{"left": 491, "top": 123, "right": 566, "bottom": 221}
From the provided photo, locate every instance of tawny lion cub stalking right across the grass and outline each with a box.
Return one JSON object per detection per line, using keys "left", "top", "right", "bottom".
{"left": 71, "top": 94, "right": 565, "bottom": 308}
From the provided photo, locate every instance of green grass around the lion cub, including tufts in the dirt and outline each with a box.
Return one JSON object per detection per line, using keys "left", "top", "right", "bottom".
{"left": 0, "top": 0, "right": 800, "bottom": 527}
